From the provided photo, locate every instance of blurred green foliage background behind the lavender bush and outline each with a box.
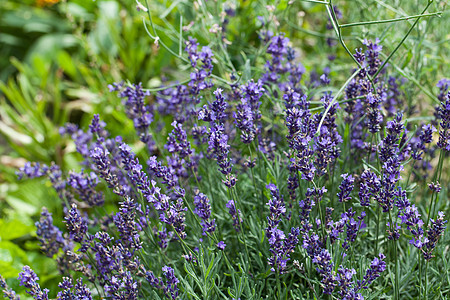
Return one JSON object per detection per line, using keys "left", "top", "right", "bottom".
{"left": 0, "top": 0, "right": 450, "bottom": 296}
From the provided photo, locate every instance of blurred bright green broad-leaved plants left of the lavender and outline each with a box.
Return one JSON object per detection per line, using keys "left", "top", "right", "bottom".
{"left": 0, "top": 1, "right": 175, "bottom": 294}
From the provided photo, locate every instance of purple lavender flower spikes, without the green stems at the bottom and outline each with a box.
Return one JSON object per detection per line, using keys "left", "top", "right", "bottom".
{"left": 4, "top": 7, "right": 450, "bottom": 299}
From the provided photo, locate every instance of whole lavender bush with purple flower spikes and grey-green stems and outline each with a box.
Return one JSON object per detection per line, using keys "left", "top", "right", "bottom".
{"left": 2, "top": 0, "right": 450, "bottom": 299}
